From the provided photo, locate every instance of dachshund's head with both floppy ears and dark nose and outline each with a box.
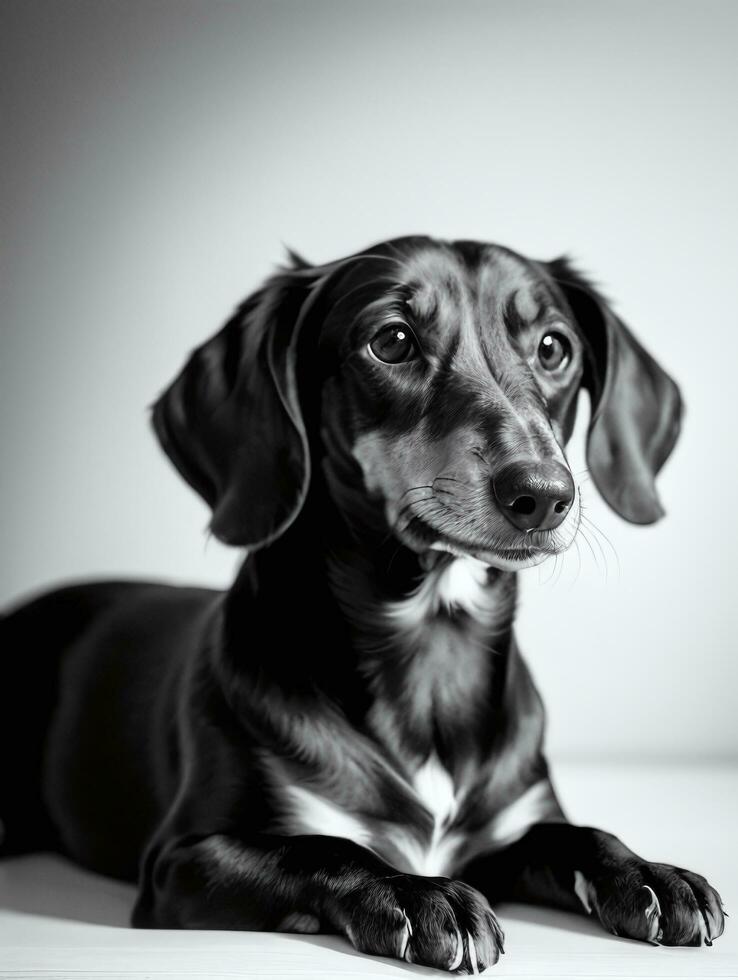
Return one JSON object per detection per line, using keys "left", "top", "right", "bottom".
{"left": 153, "top": 238, "right": 680, "bottom": 568}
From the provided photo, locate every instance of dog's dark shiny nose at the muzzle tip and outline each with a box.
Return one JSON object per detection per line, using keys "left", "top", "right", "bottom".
{"left": 492, "top": 461, "right": 574, "bottom": 531}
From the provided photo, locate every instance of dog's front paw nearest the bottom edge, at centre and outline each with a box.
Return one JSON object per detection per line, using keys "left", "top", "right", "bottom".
{"left": 342, "top": 874, "right": 504, "bottom": 973}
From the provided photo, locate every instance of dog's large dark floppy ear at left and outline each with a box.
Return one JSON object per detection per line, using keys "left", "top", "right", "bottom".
{"left": 152, "top": 255, "right": 327, "bottom": 548}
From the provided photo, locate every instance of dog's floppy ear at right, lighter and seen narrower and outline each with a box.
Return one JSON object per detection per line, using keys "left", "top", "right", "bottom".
{"left": 547, "top": 259, "right": 682, "bottom": 524}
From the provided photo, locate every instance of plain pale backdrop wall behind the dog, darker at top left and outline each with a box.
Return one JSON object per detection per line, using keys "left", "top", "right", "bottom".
{"left": 0, "top": 0, "right": 738, "bottom": 761}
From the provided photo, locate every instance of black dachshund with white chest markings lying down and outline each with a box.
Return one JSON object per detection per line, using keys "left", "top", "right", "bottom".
{"left": 2, "top": 236, "right": 724, "bottom": 973}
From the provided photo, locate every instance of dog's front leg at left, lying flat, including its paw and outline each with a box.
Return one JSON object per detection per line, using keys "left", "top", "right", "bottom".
{"left": 133, "top": 834, "right": 502, "bottom": 972}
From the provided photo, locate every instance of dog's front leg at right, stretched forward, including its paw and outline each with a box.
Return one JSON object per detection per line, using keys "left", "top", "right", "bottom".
{"left": 462, "top": 822, "right": 724, "bottom": 946}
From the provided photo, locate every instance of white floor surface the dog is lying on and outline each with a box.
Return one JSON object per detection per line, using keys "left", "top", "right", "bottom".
{"left": 0, "top": 766, "right": 738, "bottom": 980}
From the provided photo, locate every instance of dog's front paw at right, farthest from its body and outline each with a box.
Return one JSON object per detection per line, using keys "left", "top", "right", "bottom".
{"left": 574, "top": 861, "right": 727, "bottom": 946}
